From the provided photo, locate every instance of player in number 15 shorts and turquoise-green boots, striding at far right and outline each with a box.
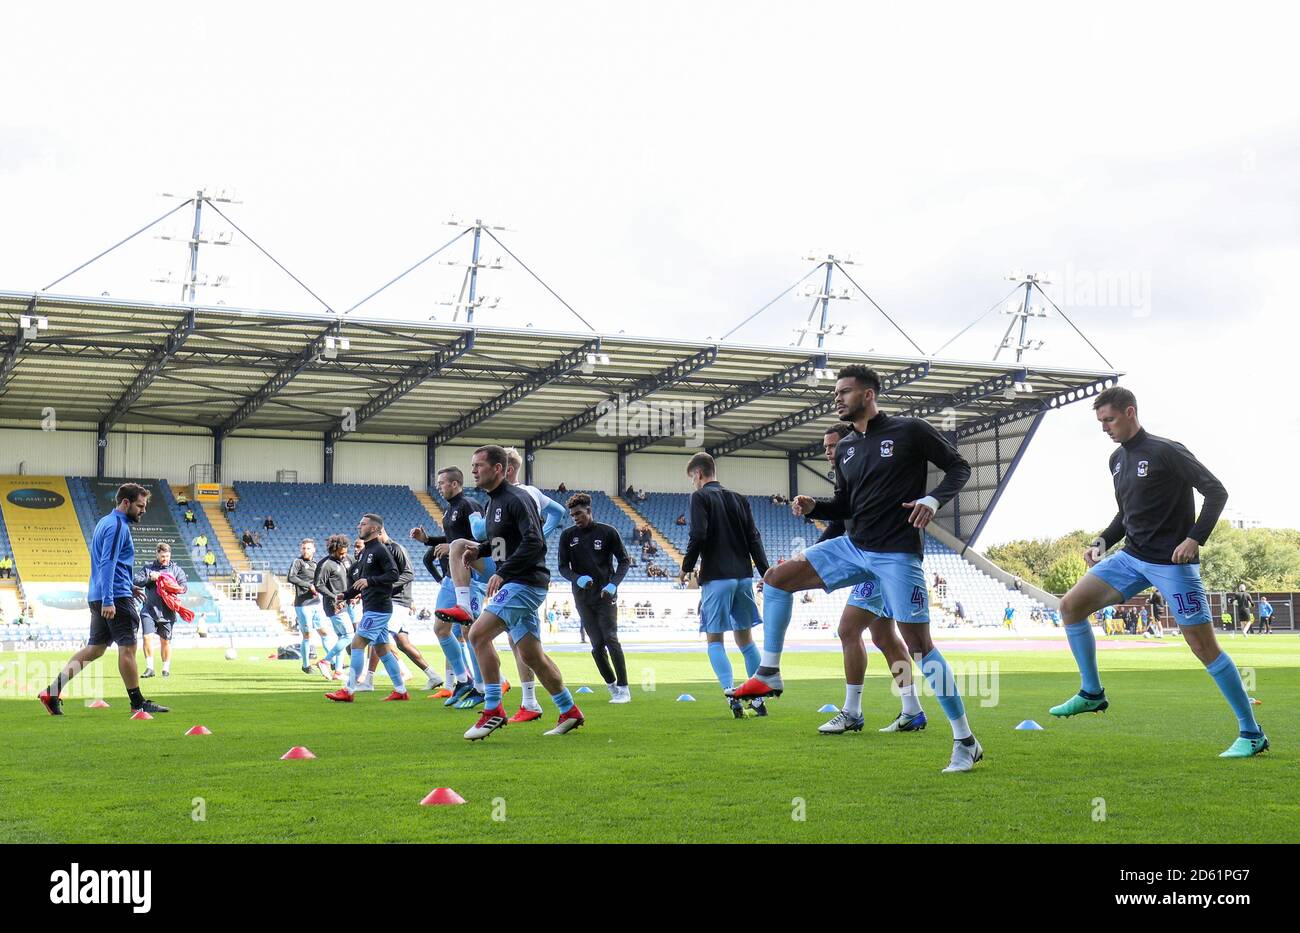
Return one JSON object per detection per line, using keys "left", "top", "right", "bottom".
{"left": 1050, "top": 386, "right": 1269, "bottom": 758}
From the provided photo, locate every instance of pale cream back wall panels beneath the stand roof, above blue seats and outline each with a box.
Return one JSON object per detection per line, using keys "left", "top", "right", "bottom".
{"left": 0, "top": 422, "right": 831, "bottom": 495}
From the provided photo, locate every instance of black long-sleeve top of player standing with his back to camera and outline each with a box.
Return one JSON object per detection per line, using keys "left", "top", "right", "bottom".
{"left": 681, "top": 479, "right": 767, "bottom": 583}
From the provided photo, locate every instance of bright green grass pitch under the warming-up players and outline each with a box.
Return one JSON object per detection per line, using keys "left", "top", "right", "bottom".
{"left": 0, "top": 644, "right": 1300, "bottom": 842}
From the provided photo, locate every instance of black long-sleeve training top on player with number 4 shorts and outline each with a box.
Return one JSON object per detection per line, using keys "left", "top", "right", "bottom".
{"left": 813, "top": 412, "right": 971, "bottom": 554}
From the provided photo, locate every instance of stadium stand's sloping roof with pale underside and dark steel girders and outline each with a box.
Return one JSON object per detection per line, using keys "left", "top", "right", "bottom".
{"left": 0, "top": 291, "right": 1118, "bottom": 455}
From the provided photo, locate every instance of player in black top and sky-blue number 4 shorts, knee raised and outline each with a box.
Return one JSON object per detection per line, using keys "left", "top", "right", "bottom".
{"left": 733, "top": 365, "right": 984, "bottom": 773}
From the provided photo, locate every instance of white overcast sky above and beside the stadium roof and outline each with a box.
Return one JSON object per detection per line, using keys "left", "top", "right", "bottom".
{"left": 0, "top": 0, "right": 1300, "bottom": 546}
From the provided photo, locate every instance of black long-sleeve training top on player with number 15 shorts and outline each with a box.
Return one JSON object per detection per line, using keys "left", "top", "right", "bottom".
{"left": 1101, "top": 429, "right": 1227, "bottom": 564}
